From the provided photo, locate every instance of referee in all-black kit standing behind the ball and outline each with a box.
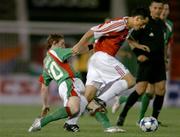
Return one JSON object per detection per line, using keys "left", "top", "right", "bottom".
{"left": 117, "top": 0, "right": 166, "bottom": 126}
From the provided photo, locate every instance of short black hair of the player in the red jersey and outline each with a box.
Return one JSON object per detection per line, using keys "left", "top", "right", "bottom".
{"left": 131, "top": 7, "right": 150, "bottom": 18}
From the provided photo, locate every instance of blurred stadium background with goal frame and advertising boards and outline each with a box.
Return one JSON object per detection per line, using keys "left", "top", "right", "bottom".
{"left": 0, "top": 0, "right": 180, "bottom": 107}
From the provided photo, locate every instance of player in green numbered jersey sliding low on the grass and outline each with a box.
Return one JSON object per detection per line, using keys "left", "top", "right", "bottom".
{"left": 28, "top": 34, "right": 87, "bottom": 132}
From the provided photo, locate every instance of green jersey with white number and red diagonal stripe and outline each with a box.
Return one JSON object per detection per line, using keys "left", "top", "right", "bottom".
{"left": 42, "top": 47, "right": 80, "bottom": 86}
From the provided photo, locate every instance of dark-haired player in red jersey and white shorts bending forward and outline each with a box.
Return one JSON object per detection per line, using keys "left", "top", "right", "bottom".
{"left": 73, "top": 8, "right": 149, "bottom": 130}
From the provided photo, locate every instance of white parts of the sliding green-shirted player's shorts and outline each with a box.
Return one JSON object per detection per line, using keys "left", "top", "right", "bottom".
{"left": 58, "top": 78, "right": 85, "bottom": 107}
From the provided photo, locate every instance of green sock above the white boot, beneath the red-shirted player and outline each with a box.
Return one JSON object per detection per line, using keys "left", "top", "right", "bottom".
{"left": 95, "top": 112, "right": 111, "bottom": 128}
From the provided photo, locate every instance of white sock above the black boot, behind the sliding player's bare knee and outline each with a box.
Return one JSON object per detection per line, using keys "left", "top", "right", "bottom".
{"left": 66, "top": 95, "right": 88, "bottom": 125}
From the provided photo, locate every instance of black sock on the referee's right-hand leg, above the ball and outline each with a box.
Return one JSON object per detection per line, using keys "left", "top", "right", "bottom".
{"left": 152, "top": 95, "right": 164, "bottom": 119}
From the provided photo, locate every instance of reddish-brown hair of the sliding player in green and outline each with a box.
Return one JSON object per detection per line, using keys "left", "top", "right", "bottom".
{"left": 47, "top": 34, "right": 64, "bottom": 50}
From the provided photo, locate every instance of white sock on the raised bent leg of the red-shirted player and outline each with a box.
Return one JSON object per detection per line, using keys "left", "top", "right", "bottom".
{"left": 98, "top": 79, "right": 128, "bottom": 102}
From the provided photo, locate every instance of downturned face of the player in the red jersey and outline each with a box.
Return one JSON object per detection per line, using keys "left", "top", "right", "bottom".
{"left": 134, "top": 16, "right": 149, "bottom": 30}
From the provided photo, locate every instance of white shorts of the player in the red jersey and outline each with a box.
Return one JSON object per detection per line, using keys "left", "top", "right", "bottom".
{"left": 86, "top": 51, "right": 129, "bottom": 89}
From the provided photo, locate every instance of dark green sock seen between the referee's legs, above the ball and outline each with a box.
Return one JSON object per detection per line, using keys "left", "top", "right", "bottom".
{"left": 139, "top": 93, "right": 151, "bottom": 122}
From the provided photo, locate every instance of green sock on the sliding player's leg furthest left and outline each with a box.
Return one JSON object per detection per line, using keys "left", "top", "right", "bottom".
{"left": 41, "top": 107, "right": 68, "bottom": 127}
